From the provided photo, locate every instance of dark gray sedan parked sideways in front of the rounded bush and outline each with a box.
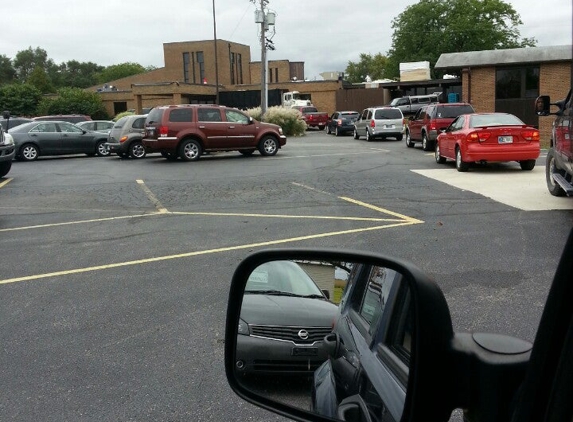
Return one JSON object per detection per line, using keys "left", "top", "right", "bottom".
{"left": 10, "top": 121, "right": 109, "bottom": 161}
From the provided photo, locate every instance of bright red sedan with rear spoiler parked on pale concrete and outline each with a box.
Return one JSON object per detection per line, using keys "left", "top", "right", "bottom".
{"left": 435, "top": 113, "right": 539, "bottom": 171}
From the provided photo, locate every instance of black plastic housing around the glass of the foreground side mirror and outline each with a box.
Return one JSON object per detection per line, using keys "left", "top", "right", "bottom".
{"left": 225, "top": 249, "right": 457, "bottom": 421}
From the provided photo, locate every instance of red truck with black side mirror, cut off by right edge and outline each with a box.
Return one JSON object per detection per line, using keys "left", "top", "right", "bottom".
{"left": 535, "top": 90, "right": 573, "bottom": 196}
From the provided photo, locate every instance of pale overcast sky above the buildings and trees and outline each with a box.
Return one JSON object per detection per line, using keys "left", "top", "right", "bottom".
{"left": 0, "top": 0, "right": 572, "bottom": 80}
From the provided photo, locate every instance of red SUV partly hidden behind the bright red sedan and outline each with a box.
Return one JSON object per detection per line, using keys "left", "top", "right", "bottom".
{"left": 406, "top": 103, "right": 475, "bottom": 151}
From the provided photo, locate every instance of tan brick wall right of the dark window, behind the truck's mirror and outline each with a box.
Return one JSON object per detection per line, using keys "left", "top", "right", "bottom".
{"left": 539, "top": 62, "right": 571, "bottom": 146}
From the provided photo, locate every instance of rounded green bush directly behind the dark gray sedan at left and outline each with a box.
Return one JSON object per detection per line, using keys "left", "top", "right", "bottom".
{"left": 38, "top": 88, "right": 109, "bottom": 119}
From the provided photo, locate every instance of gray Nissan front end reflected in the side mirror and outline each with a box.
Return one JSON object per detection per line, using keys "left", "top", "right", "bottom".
{"left": 235, "top": 261, "right": 338, "bottom": 375}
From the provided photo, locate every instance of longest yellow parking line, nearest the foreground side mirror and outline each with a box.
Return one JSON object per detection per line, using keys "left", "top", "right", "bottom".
{"left": 0, "top": 221, "right": 416, "bottom": 284}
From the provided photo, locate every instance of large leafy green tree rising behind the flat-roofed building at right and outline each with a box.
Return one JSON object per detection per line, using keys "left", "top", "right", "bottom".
{"left": 387, "top": 0, "right": 536, "bottom": 77}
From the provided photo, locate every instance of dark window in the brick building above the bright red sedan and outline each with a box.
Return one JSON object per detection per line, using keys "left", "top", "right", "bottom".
{"left": 495, "top": 66, "right": 539, "bottom": 100}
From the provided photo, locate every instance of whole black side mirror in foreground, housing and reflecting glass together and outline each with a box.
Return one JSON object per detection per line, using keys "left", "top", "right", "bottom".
{"left": 225, "top": 249, "right": 455, "bottom": 421}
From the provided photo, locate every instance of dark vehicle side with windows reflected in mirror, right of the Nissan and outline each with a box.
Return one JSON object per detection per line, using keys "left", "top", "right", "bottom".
{"left": 311, "top": 263, "right": 412, "bottom": 421}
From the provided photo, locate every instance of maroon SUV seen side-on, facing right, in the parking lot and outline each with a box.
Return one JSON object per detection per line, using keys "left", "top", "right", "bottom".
{"left": 143, "top": 104, "right": 286, "bottom": 161}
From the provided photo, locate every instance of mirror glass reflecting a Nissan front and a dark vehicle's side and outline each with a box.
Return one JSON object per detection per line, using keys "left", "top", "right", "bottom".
{"left": 229, "top": 257, "right": 415, "bottom": 421}
